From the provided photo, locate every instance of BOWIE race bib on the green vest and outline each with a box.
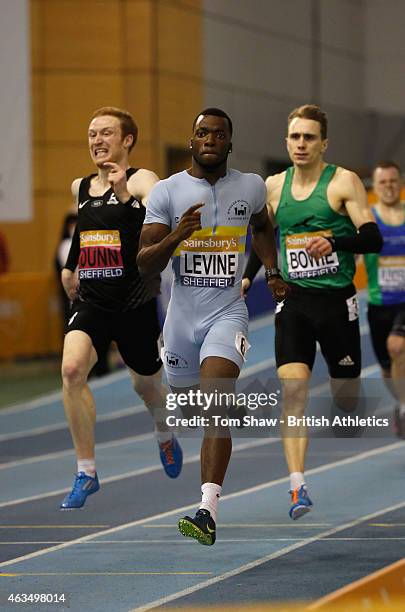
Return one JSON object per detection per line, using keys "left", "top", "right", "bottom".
{"left": 285, "top": 230, "right": 339, "bottom": 279}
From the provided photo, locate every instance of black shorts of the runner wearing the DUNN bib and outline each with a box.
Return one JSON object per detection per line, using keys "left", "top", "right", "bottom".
{"left": 66, "top": 299, "right": 162, "bottom": 376}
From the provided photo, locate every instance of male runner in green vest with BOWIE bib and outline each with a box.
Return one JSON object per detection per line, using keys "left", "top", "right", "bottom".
{"left": 243, "top": 104, "right": 382, "bottom": 520}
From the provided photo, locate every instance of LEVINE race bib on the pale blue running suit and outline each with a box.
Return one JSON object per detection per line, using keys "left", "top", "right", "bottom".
{"left": 178, "top": 235, "right": 240, "bottom": 289}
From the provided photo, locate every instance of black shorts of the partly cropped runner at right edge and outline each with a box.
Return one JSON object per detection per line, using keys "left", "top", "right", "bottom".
{"left": 367, "top": 304, "right": 405, "bottom": 370}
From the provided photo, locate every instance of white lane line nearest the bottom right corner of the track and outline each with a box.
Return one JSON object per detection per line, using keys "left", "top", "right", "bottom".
{"left": 129, "top": 502, "right": 405, "bottom": 612}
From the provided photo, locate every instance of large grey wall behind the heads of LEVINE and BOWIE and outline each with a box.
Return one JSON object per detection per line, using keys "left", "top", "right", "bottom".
{"left": 204, "top": 0, "right": 405, "bottom": 172}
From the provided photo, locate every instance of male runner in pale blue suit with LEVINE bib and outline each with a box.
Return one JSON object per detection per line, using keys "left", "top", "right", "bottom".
{"left": 137, "top": 108, "right": 286, "bottom": 545}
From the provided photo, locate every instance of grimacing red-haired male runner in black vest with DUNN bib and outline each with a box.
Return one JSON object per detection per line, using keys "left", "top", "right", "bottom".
{"left": 61, "top": 107, "right": 182, "bottom": 510}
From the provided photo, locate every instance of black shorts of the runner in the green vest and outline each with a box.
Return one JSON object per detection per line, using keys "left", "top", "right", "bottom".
{"left": 275, "top": 285, "right": 361, "bottom": 378}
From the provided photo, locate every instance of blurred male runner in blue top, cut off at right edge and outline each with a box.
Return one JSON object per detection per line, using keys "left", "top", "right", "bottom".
{"left": 364, "top": 161, "right": 405, "bottom": 438}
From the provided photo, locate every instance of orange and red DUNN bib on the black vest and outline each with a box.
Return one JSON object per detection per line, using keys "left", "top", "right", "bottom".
{"left": 79, "top": 230, "right": 124, "bottom": 280}
